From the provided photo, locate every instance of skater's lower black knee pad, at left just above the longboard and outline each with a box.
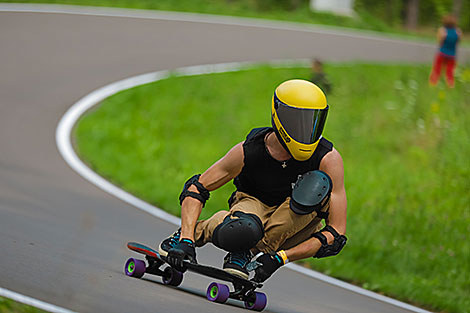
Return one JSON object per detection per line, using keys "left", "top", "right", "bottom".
{"left": 212, "top": 212, "right": 264, "bottom": 252}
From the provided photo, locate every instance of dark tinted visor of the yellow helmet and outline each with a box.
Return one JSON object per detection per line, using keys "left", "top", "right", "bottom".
{"left": 274, "top": 96, "right": 329, "bottom": 144}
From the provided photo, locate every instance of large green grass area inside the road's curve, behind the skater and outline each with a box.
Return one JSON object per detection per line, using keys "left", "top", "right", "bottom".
{"left": 75, "top": 64, "right": 470, "bottom": 312}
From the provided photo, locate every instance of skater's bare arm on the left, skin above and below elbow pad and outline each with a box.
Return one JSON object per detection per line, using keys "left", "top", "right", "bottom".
{"left": 181, "top": 142, "right": 244, "bottom": 241}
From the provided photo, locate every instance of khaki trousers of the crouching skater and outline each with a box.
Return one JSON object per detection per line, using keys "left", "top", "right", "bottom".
{"left": 194, "top": 191, "right": 329, "bottom": 253}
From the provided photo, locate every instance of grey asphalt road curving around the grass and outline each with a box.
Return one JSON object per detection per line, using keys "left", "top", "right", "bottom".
{"left": 0, "top": 7, "right": 468, "bottom": 313}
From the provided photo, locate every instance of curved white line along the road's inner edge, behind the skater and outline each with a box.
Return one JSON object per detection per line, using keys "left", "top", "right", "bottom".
{"left": 56, "top": 60, "right": 430, "bottom": 313}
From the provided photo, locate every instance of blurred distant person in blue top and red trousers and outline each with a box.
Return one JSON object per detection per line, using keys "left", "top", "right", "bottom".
{"left": 429, "top": 15, "right": 462, "bottom": 88}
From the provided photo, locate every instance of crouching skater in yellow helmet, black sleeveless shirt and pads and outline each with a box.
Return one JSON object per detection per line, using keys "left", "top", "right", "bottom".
{"left": 159, "top": 80, "right": 347, "bottom": 282}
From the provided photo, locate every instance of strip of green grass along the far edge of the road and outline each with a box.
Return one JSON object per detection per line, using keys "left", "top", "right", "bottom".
{"left": 1, "top": 0, "right": 452, "bottom": 40}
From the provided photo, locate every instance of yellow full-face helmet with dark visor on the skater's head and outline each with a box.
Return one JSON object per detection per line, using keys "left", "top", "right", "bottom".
{"left": 271, "top": 79, "right": 329, "bottom": 161}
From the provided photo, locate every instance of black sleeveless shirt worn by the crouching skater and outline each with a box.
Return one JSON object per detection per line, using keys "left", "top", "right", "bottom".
{"left": 233, "top": 127, "right": 333, "bottom": 206}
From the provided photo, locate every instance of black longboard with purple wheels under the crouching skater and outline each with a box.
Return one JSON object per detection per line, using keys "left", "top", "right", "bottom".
{"left": 124, "top": 242, "right": 267, "bottom": 311}
